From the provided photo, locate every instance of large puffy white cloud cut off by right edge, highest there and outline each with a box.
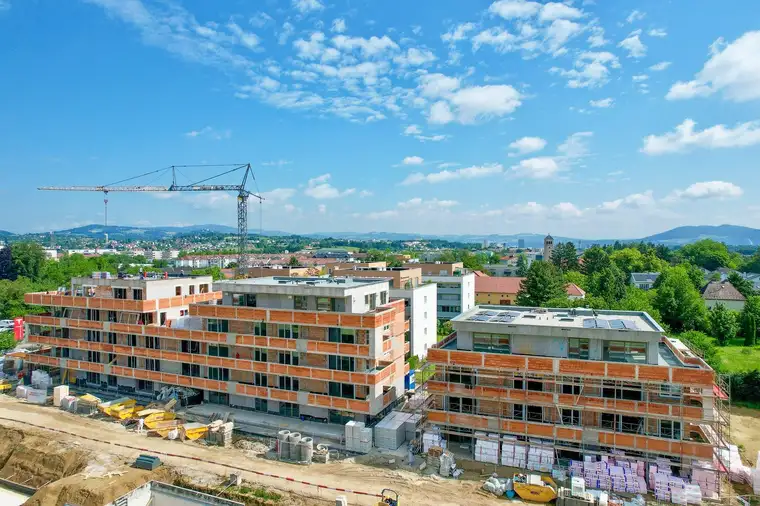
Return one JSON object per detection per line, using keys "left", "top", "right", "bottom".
{"left": 666, "top": 31, "right": 760, "bottom": 102}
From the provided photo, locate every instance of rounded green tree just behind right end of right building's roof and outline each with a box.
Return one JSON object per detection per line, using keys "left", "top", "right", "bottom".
{"left": 653, "top": 266, "right": 706, "bottom": 332}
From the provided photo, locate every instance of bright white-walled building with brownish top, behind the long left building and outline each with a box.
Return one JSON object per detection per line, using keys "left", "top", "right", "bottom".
{"left": 333, "top": 266, "right": 438, "bottom": 357}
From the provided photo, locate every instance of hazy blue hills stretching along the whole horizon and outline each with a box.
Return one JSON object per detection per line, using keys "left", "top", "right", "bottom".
{"left": 0, "top": 224, "right": 760, "bottom": 248}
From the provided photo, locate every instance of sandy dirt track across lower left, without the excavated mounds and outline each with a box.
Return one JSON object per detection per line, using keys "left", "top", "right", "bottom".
{"left": 0, "top": 396, "right": 504, "bottom": 506}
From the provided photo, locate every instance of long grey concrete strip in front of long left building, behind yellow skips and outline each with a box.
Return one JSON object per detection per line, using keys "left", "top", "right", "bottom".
{"left": 178, "top": 403, "right": 345, "bottom": 448}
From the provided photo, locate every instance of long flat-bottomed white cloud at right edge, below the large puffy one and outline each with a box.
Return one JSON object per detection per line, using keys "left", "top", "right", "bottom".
{"left": 641, "top": 119, "right": 760, "bottom": 155}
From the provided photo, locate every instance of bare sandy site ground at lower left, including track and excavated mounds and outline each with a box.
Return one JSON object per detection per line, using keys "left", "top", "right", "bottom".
{"left": 0, "top": 396, "right": 516, "bottom": 506}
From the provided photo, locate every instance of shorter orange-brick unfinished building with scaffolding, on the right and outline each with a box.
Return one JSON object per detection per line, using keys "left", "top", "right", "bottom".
{"left": 426, "top": 306, "right": 728, "bottom": 478}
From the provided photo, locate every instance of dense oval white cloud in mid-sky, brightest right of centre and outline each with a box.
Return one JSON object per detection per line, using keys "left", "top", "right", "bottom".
{"left": 428, "top": 84, "right": 523, "bottom": 125}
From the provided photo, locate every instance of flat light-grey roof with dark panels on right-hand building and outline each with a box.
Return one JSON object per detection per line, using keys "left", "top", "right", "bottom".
{"left": 451, "top": 306, "right": 664, "bottom": 333}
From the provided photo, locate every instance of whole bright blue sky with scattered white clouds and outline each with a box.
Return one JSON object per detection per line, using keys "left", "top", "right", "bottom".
{"left": 0, "top": 0, "right": 760, "bottom": 238}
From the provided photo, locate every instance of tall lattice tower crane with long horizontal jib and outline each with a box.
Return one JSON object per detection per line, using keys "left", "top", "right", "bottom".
{"left": 38, "top": 163, "right": 264, "bottom": 276}
